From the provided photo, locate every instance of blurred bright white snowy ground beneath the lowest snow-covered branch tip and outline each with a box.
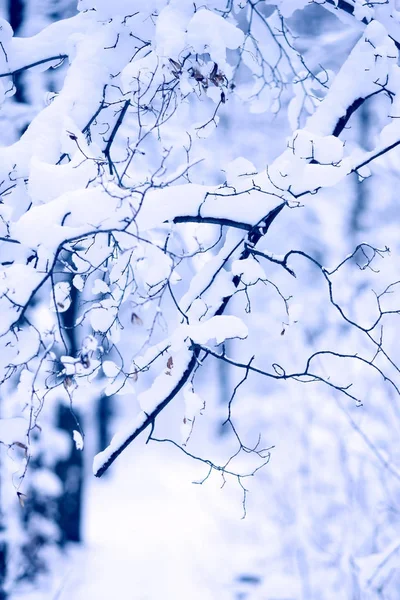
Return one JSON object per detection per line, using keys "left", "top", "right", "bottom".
{"left": 13, "top": 432, "right": 270, "bottom": 600}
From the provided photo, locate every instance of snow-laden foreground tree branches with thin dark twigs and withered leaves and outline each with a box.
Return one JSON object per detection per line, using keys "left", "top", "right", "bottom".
{"left": 0, "top": 0, "right": 400, "bottom": 510}
